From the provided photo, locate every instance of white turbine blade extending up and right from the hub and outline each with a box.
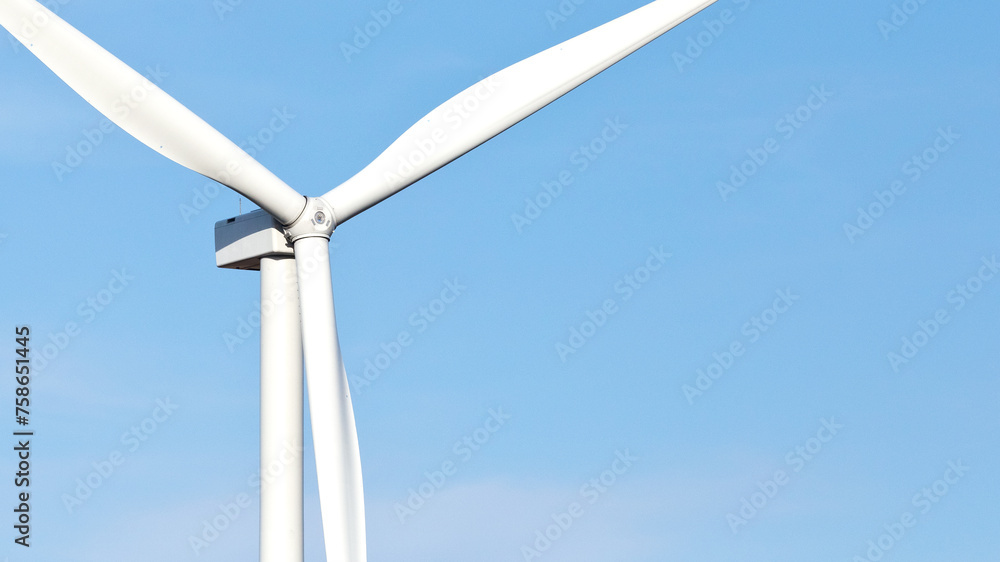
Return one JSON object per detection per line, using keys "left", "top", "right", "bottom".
{"left": 323, "top": 0, "right": 716, "bottom": 224}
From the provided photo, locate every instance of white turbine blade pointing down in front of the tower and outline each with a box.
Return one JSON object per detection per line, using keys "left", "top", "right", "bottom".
{"left": 294, "top": 237, "right": 367, "bottom": 562}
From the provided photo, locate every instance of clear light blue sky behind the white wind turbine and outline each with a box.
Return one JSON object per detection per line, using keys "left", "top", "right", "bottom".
{"left": 0, "top": 0, "right": 1000, "bottom": 562}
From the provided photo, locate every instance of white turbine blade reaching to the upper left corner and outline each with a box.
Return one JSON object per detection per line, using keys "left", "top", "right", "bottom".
{"left": 0, "top": 0, "right": 305, "bottom": 224}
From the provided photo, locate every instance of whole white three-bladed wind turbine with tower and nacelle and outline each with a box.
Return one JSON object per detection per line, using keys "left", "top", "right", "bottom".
{"left": 0, "top": 0, "right": 716, "bottom": 562}
